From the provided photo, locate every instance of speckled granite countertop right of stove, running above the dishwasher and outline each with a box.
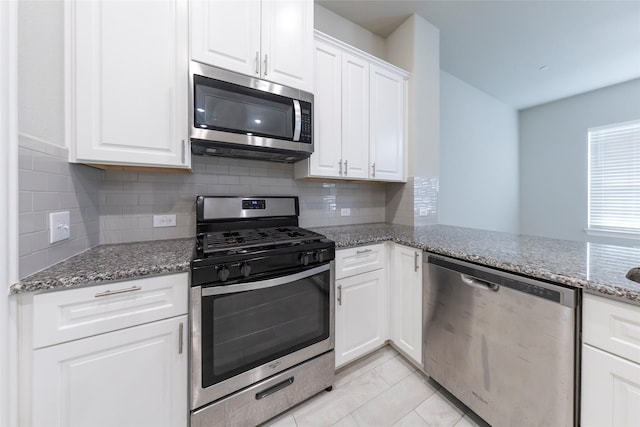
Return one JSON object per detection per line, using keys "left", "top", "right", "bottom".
{"left": 313, "top": 223, "right": 640, "bottom": 305}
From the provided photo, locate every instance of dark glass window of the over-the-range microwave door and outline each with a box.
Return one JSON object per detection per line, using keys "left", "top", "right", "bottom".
{"left": 193, "top": 76, "right": 294, "bottom": 140}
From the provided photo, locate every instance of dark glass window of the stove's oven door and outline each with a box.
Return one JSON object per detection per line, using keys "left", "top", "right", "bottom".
{"left": 202, "top": 271, "right": 331, "bottom": 387}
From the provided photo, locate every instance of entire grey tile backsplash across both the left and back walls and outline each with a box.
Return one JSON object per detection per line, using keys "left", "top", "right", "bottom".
{"left": 18, "top": 148, "right": 386, "bottom": 277}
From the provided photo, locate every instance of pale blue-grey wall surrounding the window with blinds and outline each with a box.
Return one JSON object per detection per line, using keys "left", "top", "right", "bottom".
{"left": 519, "top": 79, "right": 640, "bottom": 245}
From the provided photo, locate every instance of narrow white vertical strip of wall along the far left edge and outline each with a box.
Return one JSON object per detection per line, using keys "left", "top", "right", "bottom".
{"left": 0, "top": 1, "right": 18, "bottom": 426}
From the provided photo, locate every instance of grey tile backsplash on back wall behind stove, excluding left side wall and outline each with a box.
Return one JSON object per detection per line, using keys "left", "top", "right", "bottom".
{"left": 100, "top": 156, "right": 385, "bottom": 243}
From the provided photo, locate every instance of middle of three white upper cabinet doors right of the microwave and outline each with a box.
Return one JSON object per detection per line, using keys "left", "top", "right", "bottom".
{"left": 342, "top": 52, "right": 369, "bottom": 178}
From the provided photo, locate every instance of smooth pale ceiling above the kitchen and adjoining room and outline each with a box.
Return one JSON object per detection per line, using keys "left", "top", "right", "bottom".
{"left": 316, "top": 0, "right": 640, "bottom": 109}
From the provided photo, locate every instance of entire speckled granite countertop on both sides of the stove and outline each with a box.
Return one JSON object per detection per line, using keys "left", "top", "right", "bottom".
{"left": 9, "top": 223, "right": 640, "bottom": 305}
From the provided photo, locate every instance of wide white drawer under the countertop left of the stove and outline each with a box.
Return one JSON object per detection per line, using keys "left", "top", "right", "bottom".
{"left": 33, "top": 273, "right": 189, "bottom": 348}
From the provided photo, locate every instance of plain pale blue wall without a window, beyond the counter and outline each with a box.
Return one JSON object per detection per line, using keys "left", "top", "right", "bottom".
{"left": 439, "top": 71, "right": 518, "bottom": 232}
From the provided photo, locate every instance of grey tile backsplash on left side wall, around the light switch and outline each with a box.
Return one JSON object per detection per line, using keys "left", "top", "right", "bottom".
{"left": 18, "top": 137, "right": 103, "bottom": 277}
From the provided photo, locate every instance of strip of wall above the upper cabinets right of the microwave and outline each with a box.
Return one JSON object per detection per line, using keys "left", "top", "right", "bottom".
{"left": 313, "top": 3, "right": 385, "bottom": 59}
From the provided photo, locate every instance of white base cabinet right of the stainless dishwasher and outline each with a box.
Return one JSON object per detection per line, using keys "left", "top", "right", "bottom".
{"left": 581, "top": 294, "right": 640, "bottom": 427}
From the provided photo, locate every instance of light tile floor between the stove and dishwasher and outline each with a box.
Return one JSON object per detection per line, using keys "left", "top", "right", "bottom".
{"left": 263, "top": 346, "right": 488, "bottom": 427}
